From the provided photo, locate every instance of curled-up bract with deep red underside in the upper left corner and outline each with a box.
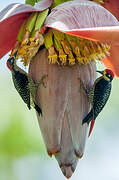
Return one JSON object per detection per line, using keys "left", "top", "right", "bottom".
{"left": 0, "top": 0, "right": 53, "bottom": 58}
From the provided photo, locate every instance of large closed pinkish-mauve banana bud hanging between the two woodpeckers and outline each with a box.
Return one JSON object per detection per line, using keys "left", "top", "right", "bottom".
{"left": 29, "top": 49, "right": 96, "bottom": 177}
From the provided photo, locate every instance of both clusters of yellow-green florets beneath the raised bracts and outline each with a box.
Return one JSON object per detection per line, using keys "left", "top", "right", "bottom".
{"left": 10, "top": 0, "right": 110, "bottom": 66}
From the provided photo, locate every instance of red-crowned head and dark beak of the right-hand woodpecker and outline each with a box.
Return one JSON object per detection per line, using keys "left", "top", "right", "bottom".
{"left": 97, "top": 69, "right": 114, "bottom": 82}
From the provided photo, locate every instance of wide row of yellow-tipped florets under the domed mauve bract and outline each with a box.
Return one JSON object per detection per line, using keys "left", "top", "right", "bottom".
{"left": 45, "top": 30, "right": 110, "bottom": 66}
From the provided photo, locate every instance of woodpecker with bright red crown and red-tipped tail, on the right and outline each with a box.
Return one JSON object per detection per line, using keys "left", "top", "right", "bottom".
{"left": 82, "top": 69, "right": 114, "bottom": 136}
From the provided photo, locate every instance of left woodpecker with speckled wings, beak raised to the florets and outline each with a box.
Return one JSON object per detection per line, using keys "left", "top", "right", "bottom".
{"left": 7, "top": 51, "right": 47, "bottom": 116}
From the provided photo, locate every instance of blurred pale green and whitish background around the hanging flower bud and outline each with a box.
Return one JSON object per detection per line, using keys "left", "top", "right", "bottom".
{"left": 0, "top": 0, "right": 119, "bottom": 180}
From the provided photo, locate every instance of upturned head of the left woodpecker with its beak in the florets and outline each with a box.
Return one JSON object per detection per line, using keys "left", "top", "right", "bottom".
{"left": 6, "top": 51, "right": 17, "bottom": 71}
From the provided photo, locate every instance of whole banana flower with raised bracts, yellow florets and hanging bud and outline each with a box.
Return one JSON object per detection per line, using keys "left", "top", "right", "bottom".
{"left": 0, "top": 0, "right": 119, "bottom": 178}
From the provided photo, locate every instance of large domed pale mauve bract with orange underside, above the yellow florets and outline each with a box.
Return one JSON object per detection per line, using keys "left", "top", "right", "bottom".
{"left": 43, "top": 1, "right": 119, "bottom": 43}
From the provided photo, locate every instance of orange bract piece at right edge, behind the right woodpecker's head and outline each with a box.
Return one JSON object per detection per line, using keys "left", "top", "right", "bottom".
{"left": 103, "top": 45, "right": 119, "bottom": 77}
